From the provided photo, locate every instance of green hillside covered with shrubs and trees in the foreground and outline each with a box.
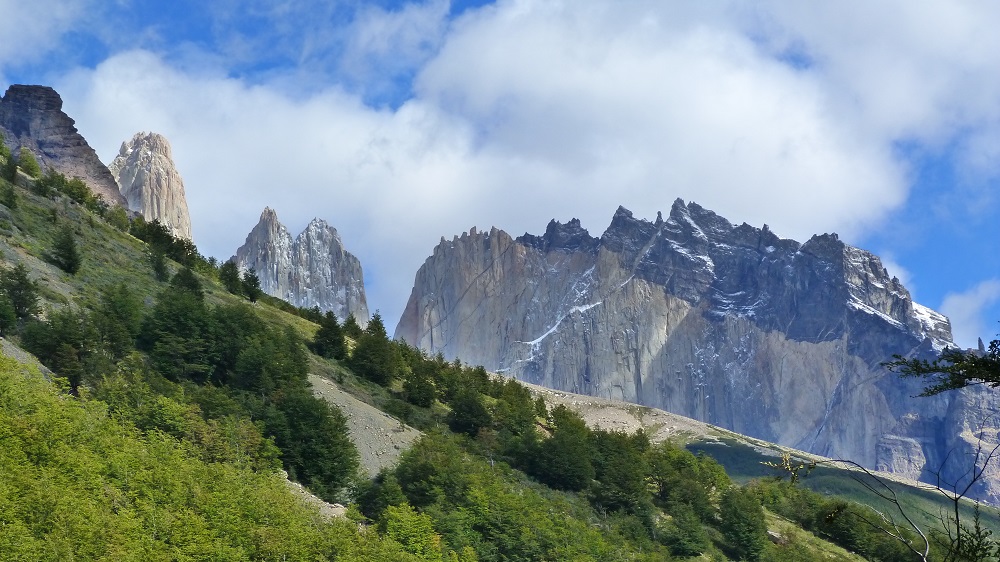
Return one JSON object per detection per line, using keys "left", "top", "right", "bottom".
{"left": 0, "top": 150, "right": 972, "bottom": 561}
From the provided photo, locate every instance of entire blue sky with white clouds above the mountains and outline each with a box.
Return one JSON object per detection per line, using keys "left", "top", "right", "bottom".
{"left": 0, "top": 0, "right": 1000, "bottom": 345}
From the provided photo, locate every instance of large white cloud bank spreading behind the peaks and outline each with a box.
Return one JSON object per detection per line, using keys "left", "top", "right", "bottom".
{"left": 41, "top": 0, "right": 1000, "bottom": 332}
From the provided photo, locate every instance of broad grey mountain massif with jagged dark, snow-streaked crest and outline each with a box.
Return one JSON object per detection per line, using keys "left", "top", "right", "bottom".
{"left": 395, "top": 200, "right": 1000, "bottom": 500}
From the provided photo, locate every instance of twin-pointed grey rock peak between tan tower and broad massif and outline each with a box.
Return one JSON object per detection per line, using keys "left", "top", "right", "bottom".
{"left": 232, "top": 207, "right": 368, "bottom": 326}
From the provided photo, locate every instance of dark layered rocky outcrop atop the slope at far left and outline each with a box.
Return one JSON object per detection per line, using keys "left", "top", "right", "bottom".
{"left": 0, "top": 85, "right": 125, "bottom": 205}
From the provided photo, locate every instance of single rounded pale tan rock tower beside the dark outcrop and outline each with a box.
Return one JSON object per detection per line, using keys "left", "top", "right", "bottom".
{"left": 108, "top": 133, "right": 192, "bottom": 240}
